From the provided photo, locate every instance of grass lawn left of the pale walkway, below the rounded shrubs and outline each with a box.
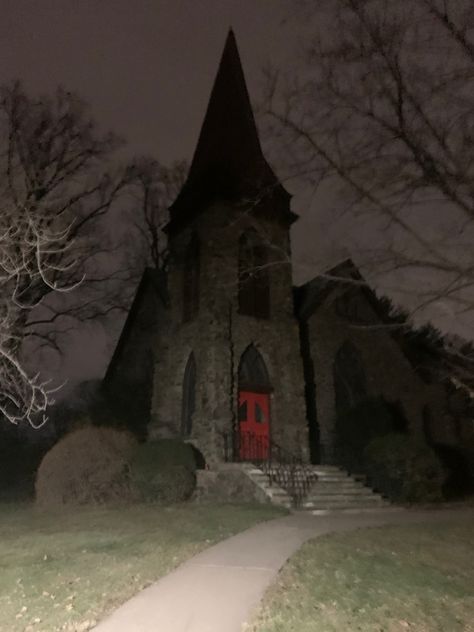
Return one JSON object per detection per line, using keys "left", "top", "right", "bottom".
{"left": 0, "top": 504, "right": 282, "bottom": 632}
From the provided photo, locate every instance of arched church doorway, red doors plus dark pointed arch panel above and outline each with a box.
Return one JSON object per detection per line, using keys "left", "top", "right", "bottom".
{"left": 238, "top": 344, "right": 272, "bottom": 461}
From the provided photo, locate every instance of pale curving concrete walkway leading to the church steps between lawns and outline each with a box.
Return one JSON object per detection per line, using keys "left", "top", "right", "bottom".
{"left": 94, "top": 508, "right": 474, "bottom": 632}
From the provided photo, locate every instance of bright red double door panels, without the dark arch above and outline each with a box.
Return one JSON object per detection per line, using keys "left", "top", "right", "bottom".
{"left": 239, "top": 391, "right": 270, "bottom": 461}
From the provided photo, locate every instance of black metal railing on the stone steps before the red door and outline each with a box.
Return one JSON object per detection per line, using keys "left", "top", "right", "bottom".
{"left": 223, "top": 432, "right": 318, "bottom": 507}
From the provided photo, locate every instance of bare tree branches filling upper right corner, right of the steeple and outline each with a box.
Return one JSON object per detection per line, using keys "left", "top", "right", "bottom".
{"left": 266, "top": 0, "right": 474, "bottom": 324}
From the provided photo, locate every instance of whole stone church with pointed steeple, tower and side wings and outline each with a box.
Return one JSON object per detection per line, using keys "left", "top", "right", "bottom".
{"left": 105, "top": 32, "right": 468, "bottom": 474}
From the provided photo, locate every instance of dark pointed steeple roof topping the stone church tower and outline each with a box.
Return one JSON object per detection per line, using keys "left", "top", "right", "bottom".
{"left": 168, "top": 30, "right": 295, "bottom": 231}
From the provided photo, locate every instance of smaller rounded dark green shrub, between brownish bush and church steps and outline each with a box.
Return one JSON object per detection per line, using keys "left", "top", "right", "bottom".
{"left": 130, "top": 439, "right": 196, "bottom": 504}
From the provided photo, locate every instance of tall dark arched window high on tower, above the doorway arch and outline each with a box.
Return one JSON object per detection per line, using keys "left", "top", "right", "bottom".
{"left": 239, "top": 230, "right": 270, "bottom": 318}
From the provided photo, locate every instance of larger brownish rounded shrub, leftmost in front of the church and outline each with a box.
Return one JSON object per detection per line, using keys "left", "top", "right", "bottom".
{"left": 35, "top": 426, "right": 137, "bottom": 505}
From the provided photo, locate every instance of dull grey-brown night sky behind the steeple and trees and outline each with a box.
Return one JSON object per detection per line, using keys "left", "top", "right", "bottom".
{"left": 0, "top": 0, "right": 473, "bottom": 388}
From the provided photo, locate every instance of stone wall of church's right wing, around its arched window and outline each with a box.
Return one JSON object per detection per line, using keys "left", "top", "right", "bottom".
{"left": 307, "top": 289, "right": 455, "bottom": 462}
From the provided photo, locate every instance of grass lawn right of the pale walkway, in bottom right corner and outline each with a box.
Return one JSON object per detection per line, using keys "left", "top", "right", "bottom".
{"left": 250, "top": 520, "right": 474, "bottom": 632}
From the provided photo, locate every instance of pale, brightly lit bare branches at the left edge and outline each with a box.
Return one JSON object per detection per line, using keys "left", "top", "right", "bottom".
{"left": 0, "top": 195, "right": 81, "bottom": 427}
